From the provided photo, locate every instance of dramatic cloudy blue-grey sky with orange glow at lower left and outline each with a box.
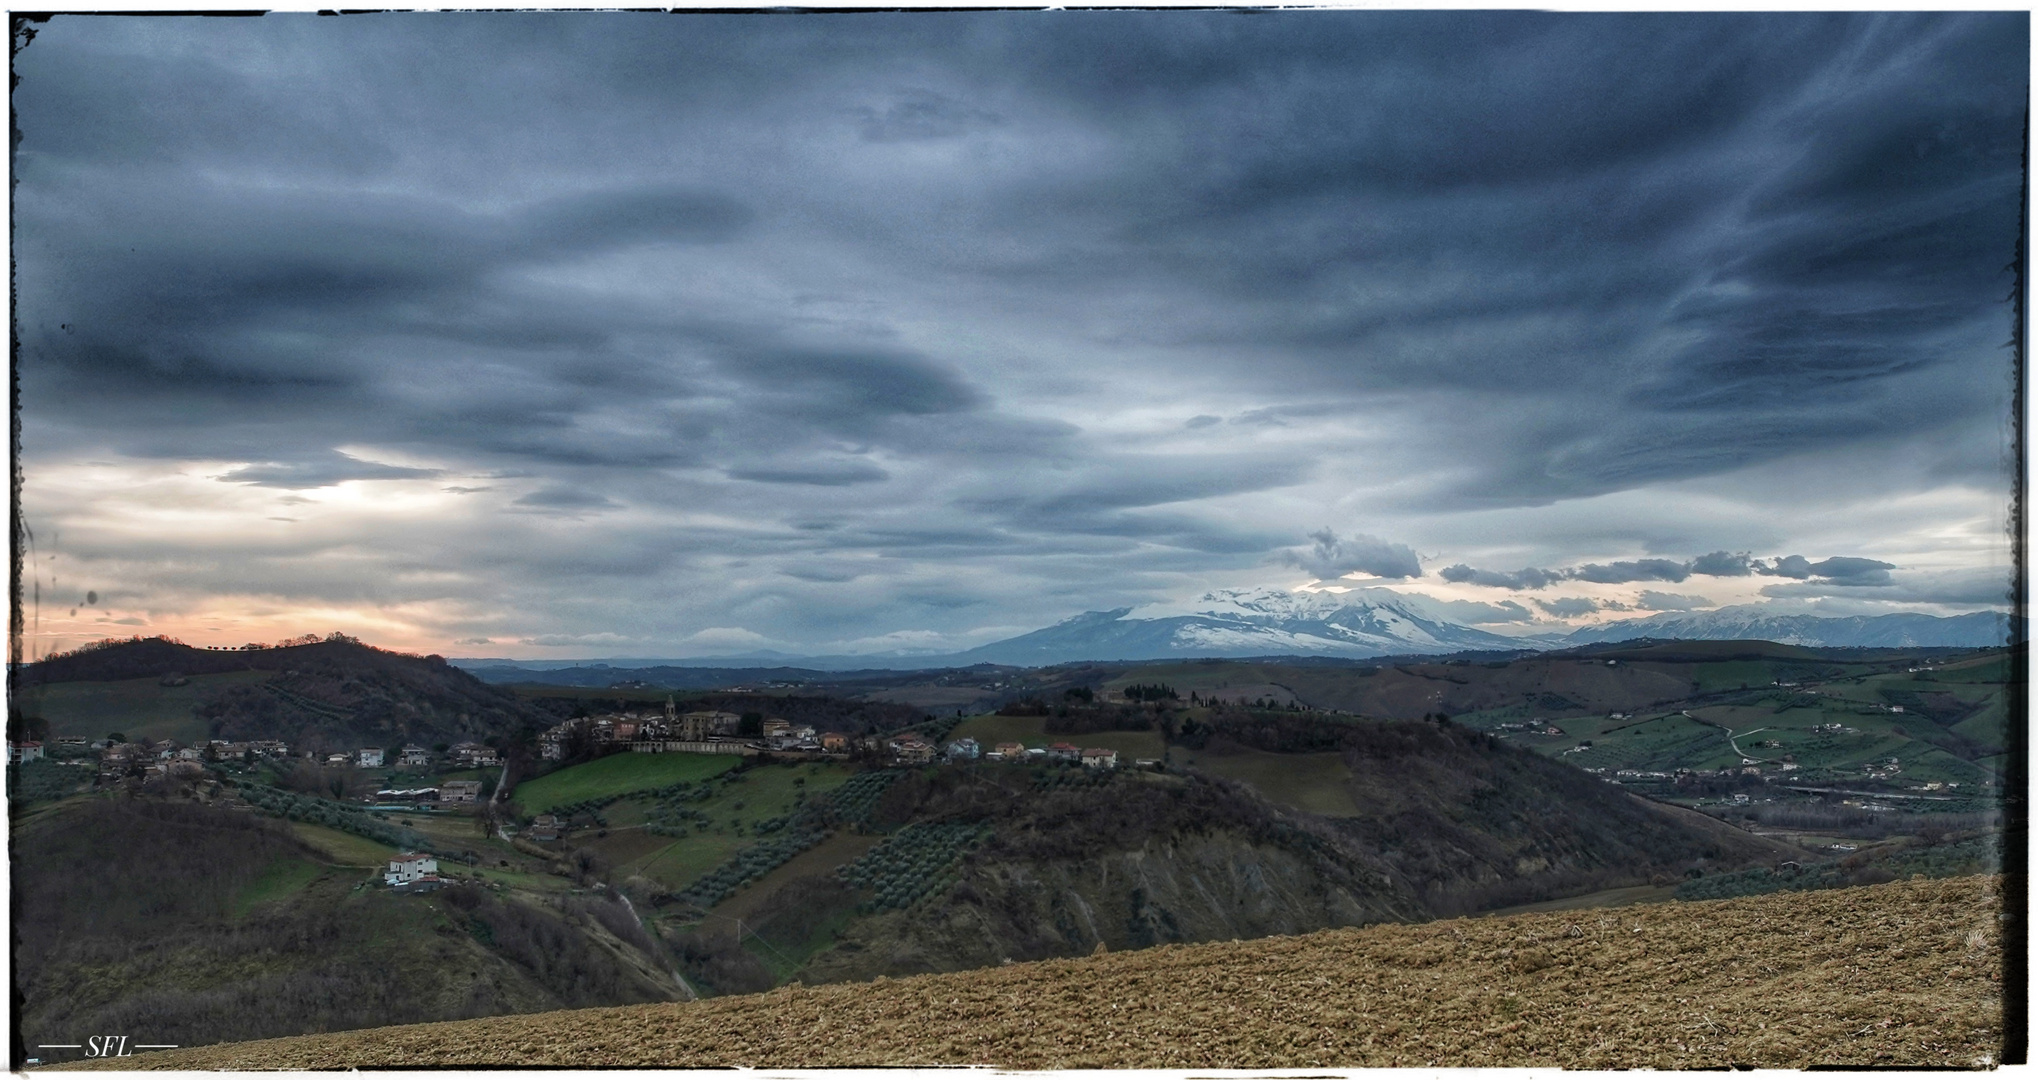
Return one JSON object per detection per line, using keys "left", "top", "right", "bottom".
{"left": 12, "top": 10, "right": 2030, "bottom": 658}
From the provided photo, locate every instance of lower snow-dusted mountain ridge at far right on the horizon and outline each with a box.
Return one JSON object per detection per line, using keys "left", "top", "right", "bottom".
{"left": 1563, "top": 603, "right": 2009, "bottom": 648}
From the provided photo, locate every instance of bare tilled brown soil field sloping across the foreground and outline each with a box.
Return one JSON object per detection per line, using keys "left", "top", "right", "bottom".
{"left": 65, "top": 878, "right": 2003, "bottom": 1070}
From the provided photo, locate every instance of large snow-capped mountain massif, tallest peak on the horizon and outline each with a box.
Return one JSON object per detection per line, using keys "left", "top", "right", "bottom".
{"left": 958, "top": 589, "right": 1545, "bottom": 666}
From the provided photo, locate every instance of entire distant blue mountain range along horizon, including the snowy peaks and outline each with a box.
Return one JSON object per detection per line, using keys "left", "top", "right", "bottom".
{"left": 452, "top": 589, "right": 2009, "bottom": 670}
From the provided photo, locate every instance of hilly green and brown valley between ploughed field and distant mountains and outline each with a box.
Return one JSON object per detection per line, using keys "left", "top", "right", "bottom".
{"left": 10, "top": 642, "right": 2014, "bottom": 1045}
